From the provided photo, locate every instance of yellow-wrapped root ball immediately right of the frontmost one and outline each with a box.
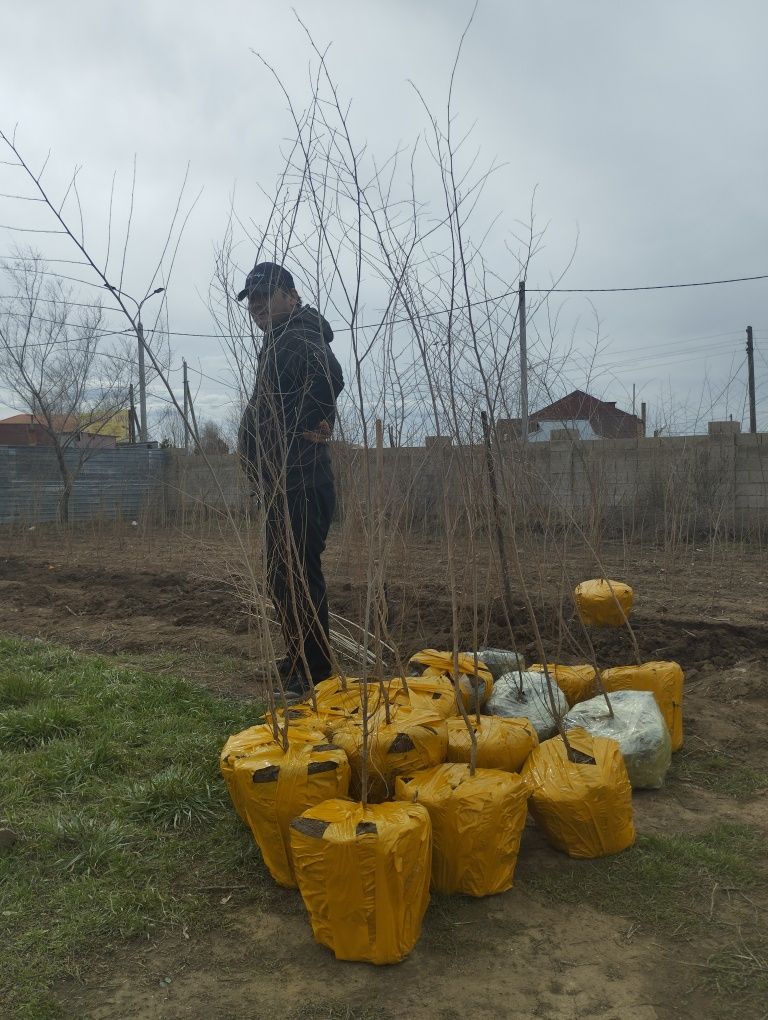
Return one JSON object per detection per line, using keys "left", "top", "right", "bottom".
{"left": 396, "top": 764, "right": 530, "bottom": 896}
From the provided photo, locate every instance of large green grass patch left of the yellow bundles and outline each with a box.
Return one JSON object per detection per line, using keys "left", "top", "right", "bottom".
{"left": 0, "top": 640, "right": 266, "bottom": 1020}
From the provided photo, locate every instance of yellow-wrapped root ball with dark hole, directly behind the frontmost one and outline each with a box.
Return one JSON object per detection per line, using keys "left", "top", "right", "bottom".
{"left": 334, "top": 708, "right": 448, "bottom": 803}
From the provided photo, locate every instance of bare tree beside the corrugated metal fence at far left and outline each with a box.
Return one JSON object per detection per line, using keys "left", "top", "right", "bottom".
{"left": 0, "top": 252, "right": 129, "bottom": 524}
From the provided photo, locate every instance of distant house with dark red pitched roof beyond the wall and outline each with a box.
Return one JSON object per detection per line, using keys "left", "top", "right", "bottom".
{"left": 496, "top": 390, "right": 646, "bottom": 443}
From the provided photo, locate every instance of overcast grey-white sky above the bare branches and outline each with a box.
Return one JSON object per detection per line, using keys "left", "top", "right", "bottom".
{"left": 0, "top": 0, "right": 768, "bottom": 430}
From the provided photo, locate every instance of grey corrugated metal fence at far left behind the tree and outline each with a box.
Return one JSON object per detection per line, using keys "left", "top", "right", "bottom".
{"left": 0, "top": 446, "right": 168, "bottom": 524}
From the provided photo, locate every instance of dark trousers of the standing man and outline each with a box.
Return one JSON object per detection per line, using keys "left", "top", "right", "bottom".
{"left": 266, "top": 485, "right": 336, "bottom": 680}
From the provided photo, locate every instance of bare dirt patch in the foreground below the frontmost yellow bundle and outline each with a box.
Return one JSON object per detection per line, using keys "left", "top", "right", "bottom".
{"left": 73, "top": 889, "right": 669, "bottom": 1020}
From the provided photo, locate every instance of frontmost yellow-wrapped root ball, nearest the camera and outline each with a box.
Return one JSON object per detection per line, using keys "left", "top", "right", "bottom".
{"left": 291, "top": 800, "right": 431, "bottom": 964}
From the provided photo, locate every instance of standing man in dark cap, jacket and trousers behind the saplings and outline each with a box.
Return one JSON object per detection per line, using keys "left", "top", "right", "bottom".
{"left": 238, "top": 262, "right": 344, "bottom": 699}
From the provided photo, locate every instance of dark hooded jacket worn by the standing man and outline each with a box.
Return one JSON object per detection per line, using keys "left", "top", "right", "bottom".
{"left": 238, "top": 307, "right": 344, "bottom": 492}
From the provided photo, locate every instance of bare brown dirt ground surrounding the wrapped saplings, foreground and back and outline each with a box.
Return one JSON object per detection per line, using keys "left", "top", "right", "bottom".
{"left": 0, "top": 532, "right": 768, "bottom": 1020}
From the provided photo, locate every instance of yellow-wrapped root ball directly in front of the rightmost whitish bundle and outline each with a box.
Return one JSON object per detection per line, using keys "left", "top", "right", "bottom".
{"left": 522, "top": 729, "right": 634, "bottom": 857}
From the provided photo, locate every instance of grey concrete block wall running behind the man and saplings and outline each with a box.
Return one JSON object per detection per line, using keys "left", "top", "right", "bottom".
{"left": 159, "top": 422, "right": 768, "bottom": 533}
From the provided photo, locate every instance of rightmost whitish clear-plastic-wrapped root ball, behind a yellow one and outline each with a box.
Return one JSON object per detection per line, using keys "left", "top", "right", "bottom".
{"left": 565, "top": 691, "right": 672, "bottom": 789}
